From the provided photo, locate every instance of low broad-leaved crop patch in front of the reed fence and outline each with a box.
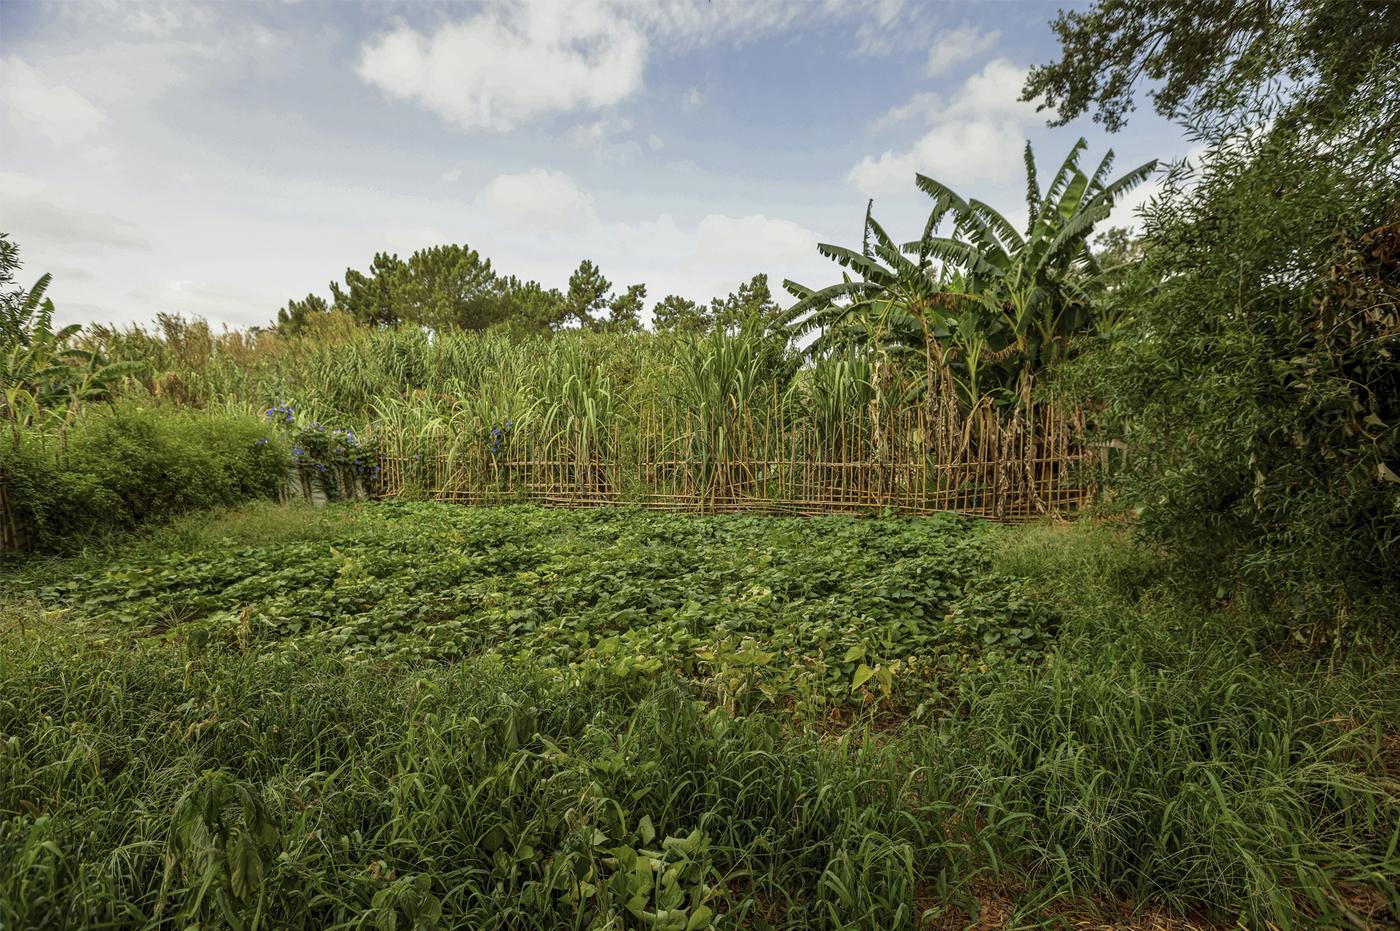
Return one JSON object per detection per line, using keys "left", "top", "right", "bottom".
{"left": 24, "top": 504, "right": 1054, "bottom": 713}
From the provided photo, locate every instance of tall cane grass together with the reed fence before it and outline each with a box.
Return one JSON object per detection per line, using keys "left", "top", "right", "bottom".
{"left": 35, "top": 314, "right": 1085, "bottom": 517}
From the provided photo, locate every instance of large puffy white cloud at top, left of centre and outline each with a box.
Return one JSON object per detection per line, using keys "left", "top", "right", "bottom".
{"left": 356, "top": 0, "right": 647, "bottom": 132}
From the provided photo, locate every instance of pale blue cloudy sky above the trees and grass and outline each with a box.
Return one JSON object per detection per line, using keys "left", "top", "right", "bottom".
{"left": 0, "top": 0, "right": 1187, "bottom": 328}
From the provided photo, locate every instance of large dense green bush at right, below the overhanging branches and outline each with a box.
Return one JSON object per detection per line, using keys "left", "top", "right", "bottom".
{"left": 1077, "top": 147, "right": 1400, "bottom": 619}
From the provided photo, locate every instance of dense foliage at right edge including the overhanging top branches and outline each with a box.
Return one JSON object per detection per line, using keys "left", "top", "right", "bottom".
{"left": 1052, "top": 0, "right": 1400, "bottom": 629}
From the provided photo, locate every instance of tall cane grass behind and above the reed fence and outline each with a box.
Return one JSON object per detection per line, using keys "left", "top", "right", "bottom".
{"left": 84, "top": 315, "right": 918, "bottom": 456}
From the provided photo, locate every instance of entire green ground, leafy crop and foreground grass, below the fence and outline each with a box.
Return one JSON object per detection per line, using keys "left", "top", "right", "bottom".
{"left": 0, "top": 503, "right": 1400, "bottom": 931}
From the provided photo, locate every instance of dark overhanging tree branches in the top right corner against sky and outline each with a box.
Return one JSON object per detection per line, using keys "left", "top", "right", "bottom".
{"left": 1022, "top": 0, "right": 1400, "bottom": 139}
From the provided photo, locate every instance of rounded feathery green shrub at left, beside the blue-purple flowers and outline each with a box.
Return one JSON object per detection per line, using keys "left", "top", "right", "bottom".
{"left": 0, "top": 406, "right": 288, "bottom": 552}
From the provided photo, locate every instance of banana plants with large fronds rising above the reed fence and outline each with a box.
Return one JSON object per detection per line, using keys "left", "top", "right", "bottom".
{"left": 781, "top": 139, "right": 1156, "bottom": 406}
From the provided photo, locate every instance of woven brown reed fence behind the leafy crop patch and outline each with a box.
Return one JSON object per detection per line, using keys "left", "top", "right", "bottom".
{"left": 379, "top": 400, "right": 1103, "bottom": 521}
